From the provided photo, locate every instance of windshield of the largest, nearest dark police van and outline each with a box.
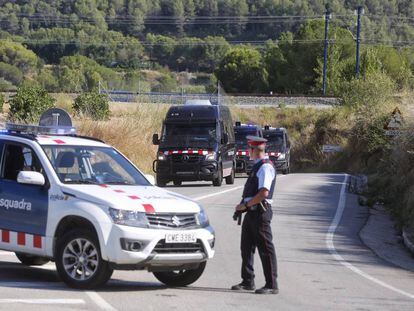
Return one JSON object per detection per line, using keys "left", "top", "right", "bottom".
{"left": 161, "top": 123, "right": 217, "bottom": 148}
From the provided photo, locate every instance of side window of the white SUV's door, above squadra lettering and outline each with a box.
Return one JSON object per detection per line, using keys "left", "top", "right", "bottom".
{"left": 2, "top": 144, "right": 44, "bottom": 181}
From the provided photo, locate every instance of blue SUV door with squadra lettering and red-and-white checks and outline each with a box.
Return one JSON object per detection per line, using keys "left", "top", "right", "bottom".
{"left": 0, "top": 140, "right": 48, "bottom": 254}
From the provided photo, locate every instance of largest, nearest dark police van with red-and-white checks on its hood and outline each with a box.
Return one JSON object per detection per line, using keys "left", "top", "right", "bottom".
{"left": 153, "top": 100, "right": 235, "bottom": 186}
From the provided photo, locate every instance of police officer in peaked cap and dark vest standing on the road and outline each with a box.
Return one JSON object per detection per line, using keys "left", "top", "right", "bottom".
{"left": 231, "top": 136, "right": 279, "bottom": 294}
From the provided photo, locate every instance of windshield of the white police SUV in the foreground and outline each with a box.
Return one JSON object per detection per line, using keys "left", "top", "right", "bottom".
{"left": 43, "top": 145, "right": 150, "bottom": 186}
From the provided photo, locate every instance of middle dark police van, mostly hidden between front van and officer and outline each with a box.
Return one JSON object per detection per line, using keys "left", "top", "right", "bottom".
{"left": 234, "top": 122, "right": 263, "bottom": 174}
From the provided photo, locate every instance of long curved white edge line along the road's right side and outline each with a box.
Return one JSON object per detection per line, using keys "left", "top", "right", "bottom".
{"left": 325, "top": 174, "right": 414, "bottom": 299}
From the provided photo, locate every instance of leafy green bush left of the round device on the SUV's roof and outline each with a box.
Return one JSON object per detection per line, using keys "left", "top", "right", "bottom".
{"left": 9, "top": 85, "right": 55, "bottom": 123}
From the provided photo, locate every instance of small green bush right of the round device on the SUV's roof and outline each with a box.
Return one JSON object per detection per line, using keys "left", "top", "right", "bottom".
{"left": 72, "top": 92, "right": 109, "bottom": 120}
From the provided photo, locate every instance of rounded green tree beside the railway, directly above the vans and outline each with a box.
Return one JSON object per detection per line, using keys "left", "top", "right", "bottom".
{"left": 215, "top": 46, "right": 268, "bottom": 93}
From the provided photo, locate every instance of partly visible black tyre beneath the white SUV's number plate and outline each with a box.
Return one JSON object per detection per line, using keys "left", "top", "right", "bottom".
{"left": 154, "top": 261, "right": 206, "bottom": 287}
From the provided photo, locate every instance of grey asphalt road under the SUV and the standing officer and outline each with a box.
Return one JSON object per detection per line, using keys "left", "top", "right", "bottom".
{"left": 0, "top": 174, "right": 414, "bottom": 311}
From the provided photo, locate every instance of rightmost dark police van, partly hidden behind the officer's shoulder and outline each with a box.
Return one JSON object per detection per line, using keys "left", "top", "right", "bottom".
{"left": 263, "top": 125, "right": 290, "bottom": 174}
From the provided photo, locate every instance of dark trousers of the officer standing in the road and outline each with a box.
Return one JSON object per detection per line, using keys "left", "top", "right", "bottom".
{"left": 241, "top": 206, "right": 278, "bottom": 288}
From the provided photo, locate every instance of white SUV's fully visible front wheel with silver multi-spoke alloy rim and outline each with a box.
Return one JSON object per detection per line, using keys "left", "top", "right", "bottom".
{"left": 55, "top": 229, "right": 113, "bottom": 289}
